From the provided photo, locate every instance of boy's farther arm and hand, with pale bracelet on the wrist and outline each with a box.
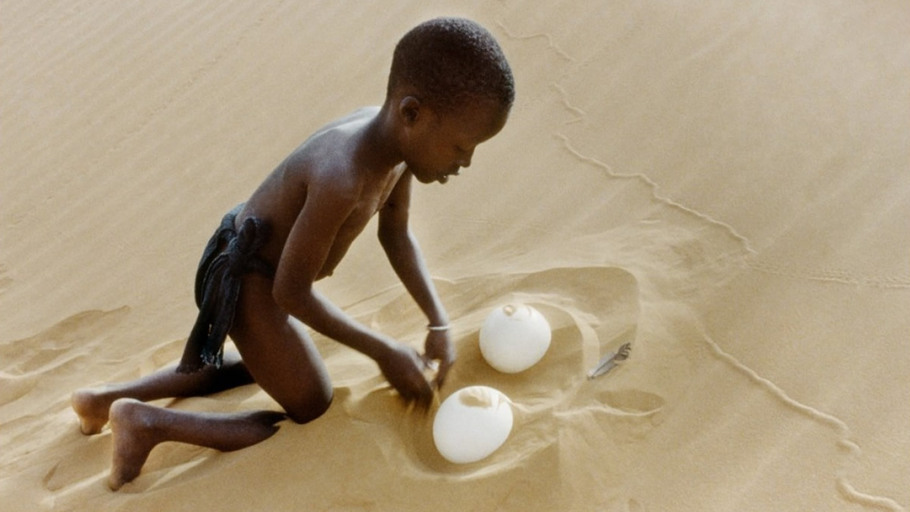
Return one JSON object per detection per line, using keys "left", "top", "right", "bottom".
{"left": 379, "top": 171, "right": 455, "bottom": 386}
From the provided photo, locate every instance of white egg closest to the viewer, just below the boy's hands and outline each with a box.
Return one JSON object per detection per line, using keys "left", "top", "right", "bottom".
{"left": 433, "top": 386, "right": 512, "bottom": 464}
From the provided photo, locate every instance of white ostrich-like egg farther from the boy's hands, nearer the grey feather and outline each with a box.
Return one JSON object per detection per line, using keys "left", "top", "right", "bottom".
{"left": 480, "top": 304, "right": 553, "bottom": 373}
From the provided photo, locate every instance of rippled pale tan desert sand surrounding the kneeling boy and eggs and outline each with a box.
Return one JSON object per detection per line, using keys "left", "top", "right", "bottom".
{"left": 0, "top": 0, "right": 910, "bottom": 511}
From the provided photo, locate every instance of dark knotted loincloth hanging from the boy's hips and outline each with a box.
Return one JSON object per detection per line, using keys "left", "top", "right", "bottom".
{"left": 177, "top": 204, "right": 275, "bottom": 373}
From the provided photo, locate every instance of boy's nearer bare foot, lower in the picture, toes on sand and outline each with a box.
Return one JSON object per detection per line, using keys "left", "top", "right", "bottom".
{"left": 108, "top": 398, "right": 160, "bottom": 491}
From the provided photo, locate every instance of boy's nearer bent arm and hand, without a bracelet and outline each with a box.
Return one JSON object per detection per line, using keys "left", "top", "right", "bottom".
{"left": 272, "top": 182, "right": 432, "bottom": 403}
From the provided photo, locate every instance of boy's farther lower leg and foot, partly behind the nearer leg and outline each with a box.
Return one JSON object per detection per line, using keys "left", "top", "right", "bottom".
{"left": 71, "top": 352, "right": 253, "bottom": 434}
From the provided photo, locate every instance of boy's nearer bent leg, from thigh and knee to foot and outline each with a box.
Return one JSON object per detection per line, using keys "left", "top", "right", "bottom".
{"left": 103, "top": 274, "right": 332, "bottom": 489}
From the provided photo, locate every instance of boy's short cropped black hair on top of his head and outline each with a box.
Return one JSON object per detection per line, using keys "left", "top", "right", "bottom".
{"left": 388, "top": 18, "right": 515, "bottom": 111}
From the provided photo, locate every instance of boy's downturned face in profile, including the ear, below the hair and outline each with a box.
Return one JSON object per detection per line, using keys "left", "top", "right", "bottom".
{"left": 405, "top": 101, "right": 508, "bottom": 183}
